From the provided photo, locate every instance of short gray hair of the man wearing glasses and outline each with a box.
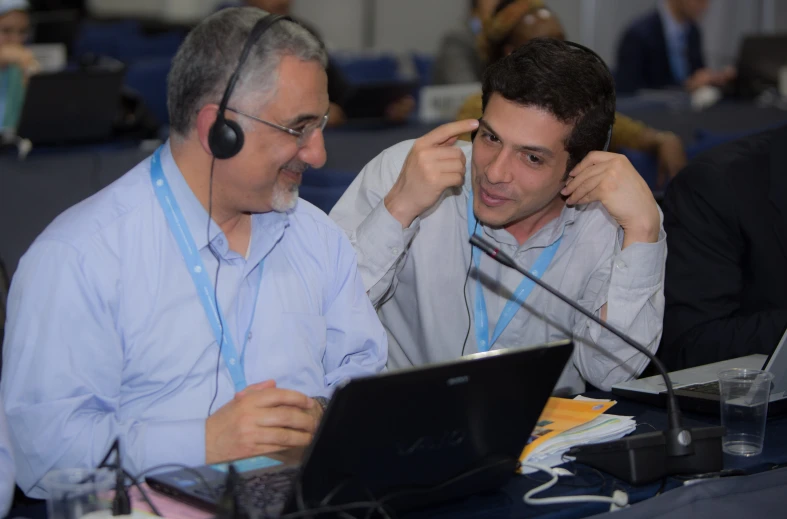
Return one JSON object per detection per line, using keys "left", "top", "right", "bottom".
{"left": 167, "top": 7, "right": 328, "bottom": 137}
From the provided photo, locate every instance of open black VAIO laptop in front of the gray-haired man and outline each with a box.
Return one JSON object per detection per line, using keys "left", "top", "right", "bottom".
{"left": 146, "top": 341, "right": 574, "bottom": 515}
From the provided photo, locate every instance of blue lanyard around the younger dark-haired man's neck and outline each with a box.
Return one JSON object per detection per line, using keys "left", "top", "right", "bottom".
{"left": 467, "top": 191, "right": 563, "bottom": 351}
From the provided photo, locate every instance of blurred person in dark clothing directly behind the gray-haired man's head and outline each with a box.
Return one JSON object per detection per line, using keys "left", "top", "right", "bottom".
{"left": 223, "top": 0, "right": 415, "bottom": 127}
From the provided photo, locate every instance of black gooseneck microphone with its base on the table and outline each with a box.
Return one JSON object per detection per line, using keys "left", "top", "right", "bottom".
{"left": 470, "top": 235, "right": 724, "bottom": 484}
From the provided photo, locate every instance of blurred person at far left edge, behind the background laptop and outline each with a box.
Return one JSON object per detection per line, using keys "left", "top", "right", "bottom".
{"left": 0, "top": 0, "right": 38, "bottom": 129}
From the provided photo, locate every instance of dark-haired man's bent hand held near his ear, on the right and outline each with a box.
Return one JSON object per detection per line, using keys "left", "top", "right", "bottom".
{"left": 560, "top": 151, "right": 661, "bottom": 249}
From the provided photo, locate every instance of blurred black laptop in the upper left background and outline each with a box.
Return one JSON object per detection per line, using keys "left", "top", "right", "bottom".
{"left": 16, "top": 67, "right": 125, "bottom": 144}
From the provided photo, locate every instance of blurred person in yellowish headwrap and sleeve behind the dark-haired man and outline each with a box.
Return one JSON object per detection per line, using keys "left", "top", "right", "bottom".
{"left": 457, "top": 0, "right": 686, "bottom": 187}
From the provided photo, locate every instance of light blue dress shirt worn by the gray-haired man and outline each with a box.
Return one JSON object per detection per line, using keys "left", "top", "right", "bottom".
{"left": 0, "top": 141, "right": 387, "bottom": 497}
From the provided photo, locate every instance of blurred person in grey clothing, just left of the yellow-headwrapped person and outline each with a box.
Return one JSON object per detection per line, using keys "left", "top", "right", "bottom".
{"left": 432, "top": 0, "right": 500, "bottom": 85}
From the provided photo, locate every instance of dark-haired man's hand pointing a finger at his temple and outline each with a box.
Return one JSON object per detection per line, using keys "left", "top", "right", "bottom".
{"left": 384, "top": 119, "right": 478, "bottom": 227}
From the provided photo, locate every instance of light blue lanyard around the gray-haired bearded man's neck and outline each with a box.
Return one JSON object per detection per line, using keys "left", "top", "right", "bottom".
{"left": 150, "top": 148, "right": 264, "bottom": 393}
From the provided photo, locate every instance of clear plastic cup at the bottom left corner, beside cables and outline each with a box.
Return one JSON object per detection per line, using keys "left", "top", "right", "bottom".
{"left": 43, "top": 469, "right": 115, "bottom": 519}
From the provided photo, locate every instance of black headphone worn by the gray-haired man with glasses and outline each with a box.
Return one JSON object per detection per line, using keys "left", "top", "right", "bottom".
{"left": 208, "top": 14, "right": 292, "bottom": 159}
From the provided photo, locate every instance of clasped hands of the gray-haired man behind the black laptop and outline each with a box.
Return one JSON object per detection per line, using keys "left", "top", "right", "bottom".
{"left": 205, "top": 381, "right": 322, "bottom": 463}
